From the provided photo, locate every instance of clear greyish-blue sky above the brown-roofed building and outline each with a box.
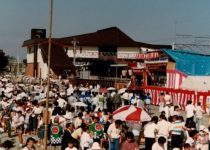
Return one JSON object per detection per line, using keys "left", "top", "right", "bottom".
{"left": 0, "top": 0, "right": 210, "bottom": 58}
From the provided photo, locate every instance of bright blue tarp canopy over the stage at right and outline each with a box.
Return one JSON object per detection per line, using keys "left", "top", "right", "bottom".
{"left": 163, "top": 49, "right": 210, "bottom": 76}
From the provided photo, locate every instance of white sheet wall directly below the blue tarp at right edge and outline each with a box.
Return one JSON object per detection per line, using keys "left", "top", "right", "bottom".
{"left": 180, "top": 76, "right": 210, "bottom": 92}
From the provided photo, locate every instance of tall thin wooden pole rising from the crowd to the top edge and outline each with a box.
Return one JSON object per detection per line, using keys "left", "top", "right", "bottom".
{"left": 44, "top": 0, "right": 53, "bottom": 150}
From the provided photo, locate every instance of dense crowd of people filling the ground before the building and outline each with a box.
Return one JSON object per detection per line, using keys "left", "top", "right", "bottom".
{"left": 0, "top": 77, "right": 209, "bottom": 150}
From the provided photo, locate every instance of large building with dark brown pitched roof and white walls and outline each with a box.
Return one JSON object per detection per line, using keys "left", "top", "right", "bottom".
{"left": 23, "top": 27, "right": 171, "bottom": 79}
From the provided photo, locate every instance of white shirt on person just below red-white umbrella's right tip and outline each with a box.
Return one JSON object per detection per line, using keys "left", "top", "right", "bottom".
{"left": 144, "top": 122, "right": 157, "bottom": 138}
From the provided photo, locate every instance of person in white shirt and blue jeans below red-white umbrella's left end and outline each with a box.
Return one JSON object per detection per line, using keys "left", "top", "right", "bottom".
{"left": 107, "top": 120, "right": 122, "bottom": 150}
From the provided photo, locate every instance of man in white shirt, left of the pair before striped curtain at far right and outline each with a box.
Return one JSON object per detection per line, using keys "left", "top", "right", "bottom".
{"left": 185, "top": 100, "right": 195, "bottom": 125}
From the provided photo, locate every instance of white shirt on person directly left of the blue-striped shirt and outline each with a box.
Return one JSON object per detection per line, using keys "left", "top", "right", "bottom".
{"left": 157, "top": 119, "right": 171, "bottom": 137}
